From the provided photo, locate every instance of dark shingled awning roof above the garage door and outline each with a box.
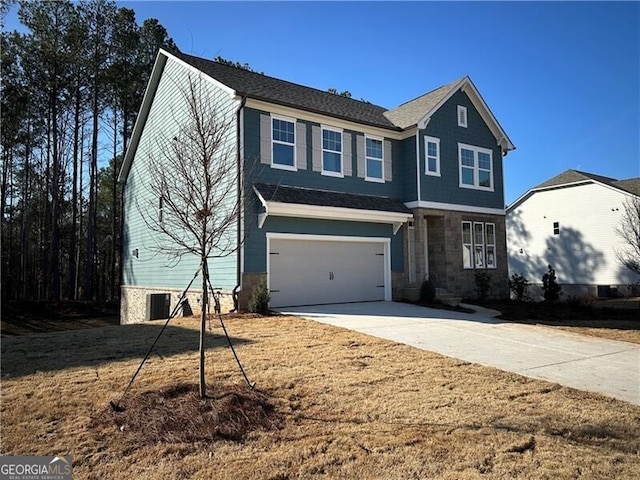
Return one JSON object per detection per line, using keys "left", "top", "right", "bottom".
{"left": 254, "top": 183, "right": 411, "bottom": 214}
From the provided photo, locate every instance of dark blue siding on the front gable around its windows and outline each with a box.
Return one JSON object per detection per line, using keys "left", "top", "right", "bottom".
{"left": 414, "top": 91, "right": 504, "bottom": 208}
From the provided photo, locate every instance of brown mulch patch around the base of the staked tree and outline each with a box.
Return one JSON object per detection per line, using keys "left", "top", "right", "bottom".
{"left": 92, "top": 383, "right": 282, "bottom": 444}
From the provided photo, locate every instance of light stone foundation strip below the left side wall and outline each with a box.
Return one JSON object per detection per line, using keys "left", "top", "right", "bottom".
{"left": 120, "top": 286, "right": 233, "bottom": 325}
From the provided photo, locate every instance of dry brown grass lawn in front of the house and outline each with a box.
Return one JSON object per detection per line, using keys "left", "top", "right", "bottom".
{"left": 0, "top": 316, "right": 640, "bottom": 480}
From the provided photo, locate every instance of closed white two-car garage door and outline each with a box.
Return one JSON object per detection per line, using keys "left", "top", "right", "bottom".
{"left": 268, "top": 236, "right": 390, "bottom": 307}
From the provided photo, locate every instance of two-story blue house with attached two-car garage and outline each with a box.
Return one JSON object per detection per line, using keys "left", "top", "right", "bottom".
{"left": 120, "top": 51, "right": 515, "bottom": 323}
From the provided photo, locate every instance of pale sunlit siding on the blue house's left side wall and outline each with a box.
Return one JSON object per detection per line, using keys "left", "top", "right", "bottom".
{"left": 122, "top": 59, "right": 239, "bottom": 289}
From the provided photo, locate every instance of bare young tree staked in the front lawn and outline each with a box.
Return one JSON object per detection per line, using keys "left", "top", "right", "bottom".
{"left": 138, "top": 76, "right": 241, "bottom": 397}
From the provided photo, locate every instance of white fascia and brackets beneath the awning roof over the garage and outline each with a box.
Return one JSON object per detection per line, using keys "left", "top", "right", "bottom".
{"left": 258, "top": 199, "right": 413, "bottom": 235}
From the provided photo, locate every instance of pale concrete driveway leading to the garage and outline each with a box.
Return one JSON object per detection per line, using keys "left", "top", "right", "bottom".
{"left": 281, "top": 302, "right": 640, "bottom": 405}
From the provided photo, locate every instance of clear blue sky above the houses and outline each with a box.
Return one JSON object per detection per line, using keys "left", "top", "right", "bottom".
{"left": 6, "top": 1, "right": 640, "bottom": 204}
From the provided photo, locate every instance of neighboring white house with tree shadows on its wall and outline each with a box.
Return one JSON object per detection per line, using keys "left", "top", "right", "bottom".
{"left": 506, "top": 170, "right": 640, "bottom": 298}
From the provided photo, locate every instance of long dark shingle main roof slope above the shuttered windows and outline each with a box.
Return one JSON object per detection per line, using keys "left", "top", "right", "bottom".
{"left": 174, "top": 53, "right": 399, "bottom": 130}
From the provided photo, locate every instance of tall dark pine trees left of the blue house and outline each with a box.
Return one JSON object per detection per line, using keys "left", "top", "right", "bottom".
{"left": 0, "top": 0, "right": 177, "bottom": 301}
